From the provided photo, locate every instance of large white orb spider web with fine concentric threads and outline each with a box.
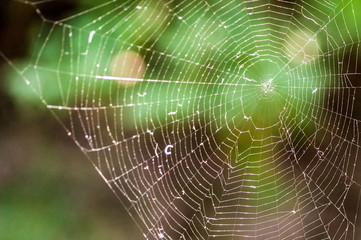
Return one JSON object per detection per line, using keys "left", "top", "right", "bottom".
{"left": 3, "top": 0, "right": 361, "bottom": 239}
